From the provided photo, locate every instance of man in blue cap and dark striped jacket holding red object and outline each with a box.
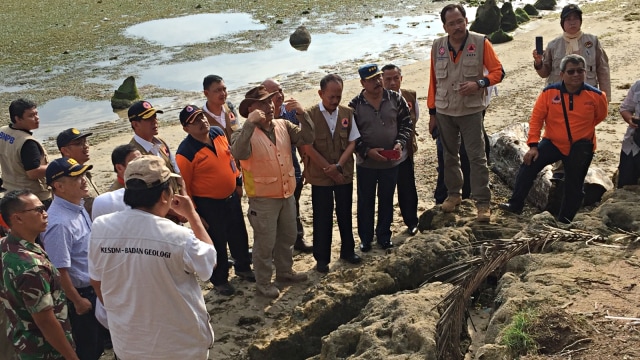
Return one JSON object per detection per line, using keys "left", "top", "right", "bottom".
{"left": 349, "top": 64, "right": 413, "bottom": 252}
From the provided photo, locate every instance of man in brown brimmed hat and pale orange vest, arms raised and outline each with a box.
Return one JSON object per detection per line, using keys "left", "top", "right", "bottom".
{"left": 231, "top": 85, "right": 314, "bottom": 298}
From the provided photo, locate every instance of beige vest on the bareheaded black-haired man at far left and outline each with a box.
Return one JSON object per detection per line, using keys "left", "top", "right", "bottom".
{"left": 0, "top": 125, "right": 51, "bottom": 201}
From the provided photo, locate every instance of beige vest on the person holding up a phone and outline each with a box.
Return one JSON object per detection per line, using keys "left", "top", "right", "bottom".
{"left": 547, "top": 34, "right": 610, "bottom": 87}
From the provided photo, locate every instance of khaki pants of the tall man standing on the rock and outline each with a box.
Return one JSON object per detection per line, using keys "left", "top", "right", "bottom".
{"left": 436, "top": 111, "right": 491, "bottom": 205}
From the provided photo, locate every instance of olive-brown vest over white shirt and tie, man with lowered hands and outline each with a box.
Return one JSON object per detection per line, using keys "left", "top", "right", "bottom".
{"left": 304, "top": 105, "right": 353, "bottom": 186}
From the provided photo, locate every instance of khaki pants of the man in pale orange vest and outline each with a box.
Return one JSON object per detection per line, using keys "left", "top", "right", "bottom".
{"left": 247, "top": 196, "right": 298, "bottom": 284}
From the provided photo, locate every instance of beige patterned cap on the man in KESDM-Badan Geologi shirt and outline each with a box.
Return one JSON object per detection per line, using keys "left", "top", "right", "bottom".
{"left": 124, "top": 155, "right": 180, "bottom": 190}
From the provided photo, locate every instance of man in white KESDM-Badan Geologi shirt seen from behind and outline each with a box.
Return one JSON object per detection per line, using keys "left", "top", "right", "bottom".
{"left": 89, "top": 155, "right": 216, "bottom": 360}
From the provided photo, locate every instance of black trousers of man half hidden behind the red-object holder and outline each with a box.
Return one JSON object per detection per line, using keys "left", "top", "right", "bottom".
{"left": 397, "top": 156, "right": 418, "bottom": 229}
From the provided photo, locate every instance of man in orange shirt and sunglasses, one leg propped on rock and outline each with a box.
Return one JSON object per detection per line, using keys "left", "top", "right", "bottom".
{"left": 500, "top": 55, "right": 608, "bottom": 224}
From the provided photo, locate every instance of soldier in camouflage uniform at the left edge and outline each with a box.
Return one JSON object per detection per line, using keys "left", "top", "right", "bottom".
{"left": 0, "top": 190, "right": 78, "bottom": 359}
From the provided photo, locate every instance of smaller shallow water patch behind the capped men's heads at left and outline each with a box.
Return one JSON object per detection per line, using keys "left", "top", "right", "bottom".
{"left": 34, "top": 96, "right": 175, "bottom": 140}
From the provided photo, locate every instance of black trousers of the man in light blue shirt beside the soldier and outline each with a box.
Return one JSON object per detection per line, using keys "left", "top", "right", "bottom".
{"left": 67, "top": 286, "right": 107, "bottom": 360}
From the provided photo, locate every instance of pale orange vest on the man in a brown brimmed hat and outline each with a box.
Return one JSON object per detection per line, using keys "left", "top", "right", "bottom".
{"left": 240, "top": 119, "right": 296, "bottom": 199}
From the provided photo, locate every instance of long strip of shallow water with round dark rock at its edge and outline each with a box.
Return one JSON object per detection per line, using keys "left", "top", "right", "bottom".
{"left": 136, "top": 14, "right": 442, "bottom": 91}
